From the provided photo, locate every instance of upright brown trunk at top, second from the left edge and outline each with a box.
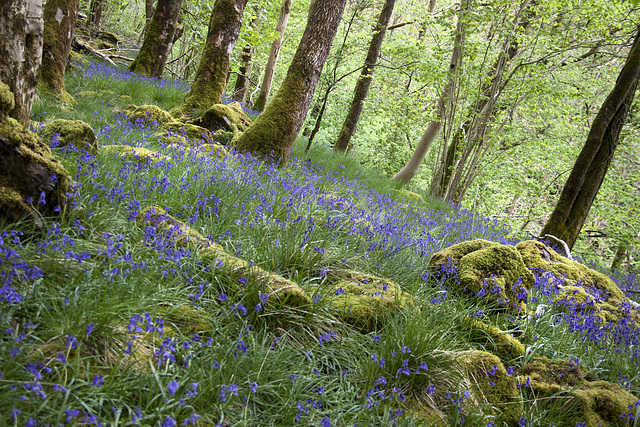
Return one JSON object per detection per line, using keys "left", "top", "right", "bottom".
{"left": 39, "top": 0, "right": 79, "bottom": 102}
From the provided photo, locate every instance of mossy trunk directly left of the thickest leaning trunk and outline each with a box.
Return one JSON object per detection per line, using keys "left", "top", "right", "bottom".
{"left": 180, "top": 0, "right": 247, "bottom": 114}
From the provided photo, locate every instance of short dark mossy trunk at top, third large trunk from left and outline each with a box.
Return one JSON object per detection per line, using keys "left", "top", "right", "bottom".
{"left": 129, "top": 0, "right": 182, "bottom": 78}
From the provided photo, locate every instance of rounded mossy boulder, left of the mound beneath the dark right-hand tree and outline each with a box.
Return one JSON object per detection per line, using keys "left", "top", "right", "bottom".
{"left": 429, "top": 239, "right": 535, "bottom": 312}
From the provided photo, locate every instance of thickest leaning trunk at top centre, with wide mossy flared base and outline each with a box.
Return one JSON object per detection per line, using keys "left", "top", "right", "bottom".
{"left": 238, "top": 0, "right": 346, "bottom": 165}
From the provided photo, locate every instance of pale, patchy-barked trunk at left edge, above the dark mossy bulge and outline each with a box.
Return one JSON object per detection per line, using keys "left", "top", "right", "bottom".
{"left": 0, "top": 0, "right": 43, "bottom": 125}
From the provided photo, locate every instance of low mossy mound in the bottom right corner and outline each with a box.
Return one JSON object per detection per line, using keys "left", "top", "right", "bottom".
{"left": 518, "top": 357, "right": 638, "bottom": 427}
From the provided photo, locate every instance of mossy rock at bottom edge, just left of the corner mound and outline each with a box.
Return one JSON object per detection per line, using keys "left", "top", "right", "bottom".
{"left": 462, "top": 351, "right": 522, "bottom": 425}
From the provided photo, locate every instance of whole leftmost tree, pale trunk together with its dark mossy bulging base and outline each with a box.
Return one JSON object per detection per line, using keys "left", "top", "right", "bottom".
{"left": 0, "top": 0, "right": 71, "bottom": 225}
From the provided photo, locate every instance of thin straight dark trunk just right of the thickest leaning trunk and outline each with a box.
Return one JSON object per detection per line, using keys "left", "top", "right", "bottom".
{"left": 333, "top": 0, "right": 395, "bottom": 152}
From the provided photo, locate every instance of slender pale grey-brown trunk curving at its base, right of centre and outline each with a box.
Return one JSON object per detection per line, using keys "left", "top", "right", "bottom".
{"left": 393, "top": 0, "right": 470, "bottom": 184}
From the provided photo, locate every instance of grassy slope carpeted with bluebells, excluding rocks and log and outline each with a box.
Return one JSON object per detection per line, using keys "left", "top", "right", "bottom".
{"left": 0, "top": 58, "right": 640, "bottom": 426}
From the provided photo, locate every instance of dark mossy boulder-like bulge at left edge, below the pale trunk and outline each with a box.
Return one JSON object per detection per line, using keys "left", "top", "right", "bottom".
{"left": 0, "top": 82, "right": 72, "bottom": 224}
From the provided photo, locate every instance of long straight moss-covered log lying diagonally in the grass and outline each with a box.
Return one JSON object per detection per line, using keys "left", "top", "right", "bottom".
{"left": 136, "top": 207, "right": 312, "bottom": 307}
